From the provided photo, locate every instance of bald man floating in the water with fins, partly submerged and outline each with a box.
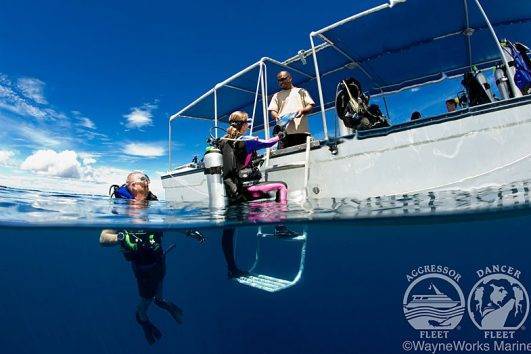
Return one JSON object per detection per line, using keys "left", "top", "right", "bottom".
{"left": 100, "top": 171, "right": 205, "bottom": 345}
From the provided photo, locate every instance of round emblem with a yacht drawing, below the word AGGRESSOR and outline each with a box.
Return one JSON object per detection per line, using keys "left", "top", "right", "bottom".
{"left": 403, "top": 273, "right": 465, "bottom": 330}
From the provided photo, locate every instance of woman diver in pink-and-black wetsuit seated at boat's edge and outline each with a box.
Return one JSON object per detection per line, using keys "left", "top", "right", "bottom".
{"left": 220, "top": 111, "right": 288, "bottom": 204}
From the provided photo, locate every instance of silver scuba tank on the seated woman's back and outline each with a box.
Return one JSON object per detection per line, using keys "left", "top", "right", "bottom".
{"left": 204, "top": 147, "right": 227, "bottom": 208}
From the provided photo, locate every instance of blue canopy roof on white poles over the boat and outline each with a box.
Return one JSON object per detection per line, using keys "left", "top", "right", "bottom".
{"left": 170, "top": 0, "right": 531, "bottom": 130}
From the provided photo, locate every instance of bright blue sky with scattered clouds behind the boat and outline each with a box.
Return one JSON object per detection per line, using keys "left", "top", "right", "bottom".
{"left": 0, "top": 0, "right": 474, "bottom": 194}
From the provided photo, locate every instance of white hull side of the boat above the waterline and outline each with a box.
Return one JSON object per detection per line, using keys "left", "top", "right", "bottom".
{"left": 162, "top": 96, "right": 531, "bottom": 201}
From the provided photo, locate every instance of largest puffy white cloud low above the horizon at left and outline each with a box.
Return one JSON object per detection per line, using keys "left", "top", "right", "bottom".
{"left": 20, "top": 150, "right": 82, "bottom": 178}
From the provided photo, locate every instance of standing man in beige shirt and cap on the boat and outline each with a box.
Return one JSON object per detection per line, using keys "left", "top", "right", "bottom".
{"left": 268, "top": 71, "right": 315, "bottom": 148}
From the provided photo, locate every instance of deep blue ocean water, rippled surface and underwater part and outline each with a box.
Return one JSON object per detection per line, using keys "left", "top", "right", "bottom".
{"left": 0, "top": 181, "right": 531, "bottom": 354}
